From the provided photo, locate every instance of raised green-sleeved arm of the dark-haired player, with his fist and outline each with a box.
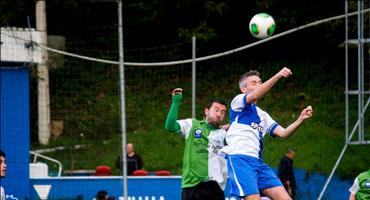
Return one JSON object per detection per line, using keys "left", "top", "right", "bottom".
{"left": 165, "top": 88, "right": 182, "bottom": 132}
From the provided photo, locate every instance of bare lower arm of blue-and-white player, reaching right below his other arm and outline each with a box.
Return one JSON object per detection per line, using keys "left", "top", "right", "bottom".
{"left": 274, "top": 106, "right": 313, "bottom": 138}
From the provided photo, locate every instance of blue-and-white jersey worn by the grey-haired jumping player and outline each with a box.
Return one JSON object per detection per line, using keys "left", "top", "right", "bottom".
{"left": 221, "top": 94, "right": 279, "bottom": 159}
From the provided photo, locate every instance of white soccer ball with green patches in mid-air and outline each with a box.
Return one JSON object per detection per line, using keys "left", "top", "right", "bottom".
{"left": 249, "top": 13, "right": 275, "bottom": 39}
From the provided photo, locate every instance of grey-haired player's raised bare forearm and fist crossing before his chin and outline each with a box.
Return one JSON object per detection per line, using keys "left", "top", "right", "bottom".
{"left": 246, "top": 67, "right": 292, "bottom": 103}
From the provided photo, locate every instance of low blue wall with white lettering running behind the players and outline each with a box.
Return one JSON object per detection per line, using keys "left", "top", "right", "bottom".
{"left": 30, "top": 169, "right": 353, "bottom": 200}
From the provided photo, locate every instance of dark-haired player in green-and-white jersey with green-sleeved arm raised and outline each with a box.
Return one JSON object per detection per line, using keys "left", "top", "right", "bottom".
{"left": 165, "top": 88, "right": 227, "bottom": 200}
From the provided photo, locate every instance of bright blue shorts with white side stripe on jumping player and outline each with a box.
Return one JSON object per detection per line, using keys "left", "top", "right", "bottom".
{"left": 227, "top": 155, "right": 282, "bottom": 197}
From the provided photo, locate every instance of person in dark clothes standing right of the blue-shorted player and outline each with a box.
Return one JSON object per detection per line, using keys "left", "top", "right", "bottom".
{"left": 278, "top": 149, "right": 297, "bottom": 199}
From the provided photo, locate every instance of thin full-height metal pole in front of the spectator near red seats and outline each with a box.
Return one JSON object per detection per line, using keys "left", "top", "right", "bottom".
{"left": 118, "top": 0, "right": 128, "bottom": 200}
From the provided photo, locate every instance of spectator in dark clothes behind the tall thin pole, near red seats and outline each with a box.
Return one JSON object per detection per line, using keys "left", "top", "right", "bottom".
{"left": 116, "top": 143, "right": 143, "bottom": 175}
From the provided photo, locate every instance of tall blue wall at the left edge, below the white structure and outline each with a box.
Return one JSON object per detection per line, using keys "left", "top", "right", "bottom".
{"left": 0, "top": 66, "right": 30, "bottom": 199}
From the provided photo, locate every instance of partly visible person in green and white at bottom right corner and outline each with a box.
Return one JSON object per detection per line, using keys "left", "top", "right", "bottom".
{"left": 349, "top": 169, "right": 370, "bottom": 200}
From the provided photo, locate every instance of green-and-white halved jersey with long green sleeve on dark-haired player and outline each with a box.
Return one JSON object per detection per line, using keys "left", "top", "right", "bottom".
{"left": 166, "top": 95, "right": 227, "bottom": 190}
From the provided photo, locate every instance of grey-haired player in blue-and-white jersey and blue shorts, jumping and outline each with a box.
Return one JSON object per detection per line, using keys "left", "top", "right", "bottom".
{"left": 220, "top": 67, "right": 313, "bottom": 200}
